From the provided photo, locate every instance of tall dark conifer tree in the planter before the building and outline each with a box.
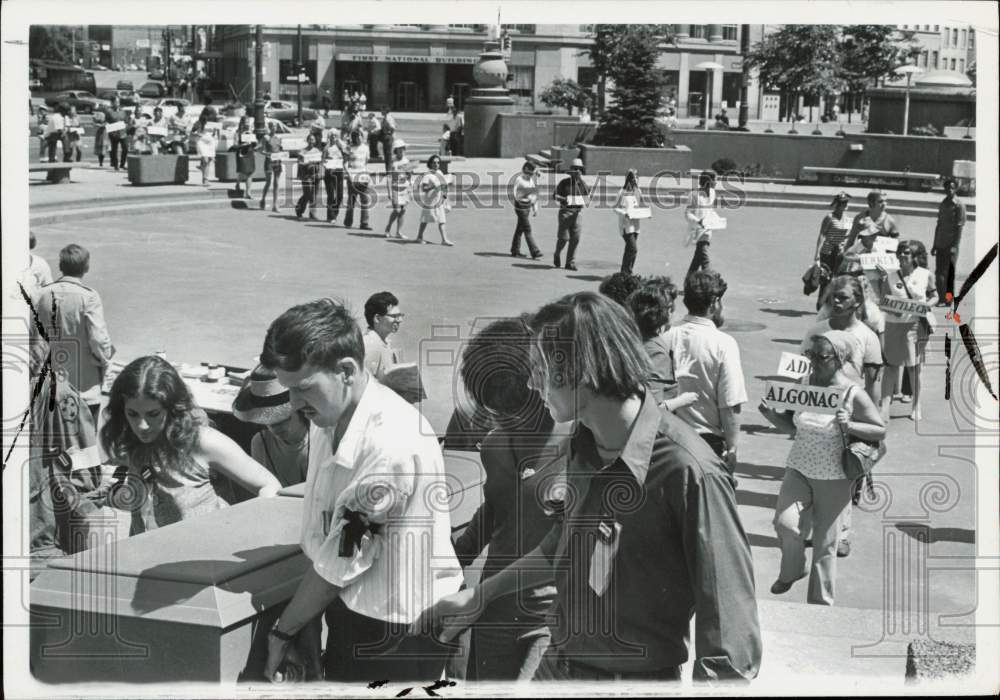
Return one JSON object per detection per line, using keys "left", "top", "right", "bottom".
{"left": 588, "top": 24, "right": 669, "bottom": 148}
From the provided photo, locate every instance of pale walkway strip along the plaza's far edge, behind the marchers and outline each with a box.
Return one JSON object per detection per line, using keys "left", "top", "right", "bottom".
{"left": 28, "top": 158, "right": 975, "bottom": 223}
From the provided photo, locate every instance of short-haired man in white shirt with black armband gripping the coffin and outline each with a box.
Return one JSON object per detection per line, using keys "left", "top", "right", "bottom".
{"left": 261, "top": 299, "right": 462, "bottom": 682}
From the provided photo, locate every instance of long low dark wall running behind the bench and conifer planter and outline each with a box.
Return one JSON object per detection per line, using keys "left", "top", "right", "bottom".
{"left": 549, "top": 122, "right": 976, "bottom": 178}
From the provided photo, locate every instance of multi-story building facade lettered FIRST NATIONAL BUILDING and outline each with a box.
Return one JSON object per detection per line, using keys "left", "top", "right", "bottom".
{"left": 215, "top": 24, "right": 761, "bottom": 116}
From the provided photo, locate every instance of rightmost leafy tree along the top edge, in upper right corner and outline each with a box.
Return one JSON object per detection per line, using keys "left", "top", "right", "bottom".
{"left": 840, "top": 24, "right": 920, "bottom": 121}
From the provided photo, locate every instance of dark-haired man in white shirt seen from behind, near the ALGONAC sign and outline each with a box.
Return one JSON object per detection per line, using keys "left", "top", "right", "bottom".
{"left": 663, "top": 270, "right": 747, "bottom": 473}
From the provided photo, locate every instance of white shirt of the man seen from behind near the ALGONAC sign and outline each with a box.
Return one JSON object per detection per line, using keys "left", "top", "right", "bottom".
{"left": 664, "top": 314, "right": 747, "bottom": 437}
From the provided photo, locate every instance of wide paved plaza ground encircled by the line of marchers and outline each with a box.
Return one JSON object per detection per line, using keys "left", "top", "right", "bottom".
{"left": 34, "top": 194, "right": 984, "bottom": 626}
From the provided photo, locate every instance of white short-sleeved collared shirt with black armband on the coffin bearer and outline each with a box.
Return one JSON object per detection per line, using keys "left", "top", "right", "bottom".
{"left": 301, "top": 376, "right": 462, "bottom": 624}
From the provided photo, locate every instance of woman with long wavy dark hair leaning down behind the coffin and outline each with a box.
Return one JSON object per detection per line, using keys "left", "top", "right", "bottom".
{"left": 101, "top": 356, "right": 281, "bottom": 534}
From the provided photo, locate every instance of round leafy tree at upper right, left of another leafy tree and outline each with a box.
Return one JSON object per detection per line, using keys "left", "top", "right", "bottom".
{"left": 746, "top": 24, "right": 844, "bottom": 123}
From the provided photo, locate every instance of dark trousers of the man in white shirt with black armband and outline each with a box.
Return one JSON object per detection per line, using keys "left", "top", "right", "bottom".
{"left": 324, "top": 598, "right": 452, "bottom": 685}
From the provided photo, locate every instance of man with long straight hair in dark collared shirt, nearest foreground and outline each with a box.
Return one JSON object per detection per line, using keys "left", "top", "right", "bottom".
{"left": 414, "top": 292, "right": 761, "bottom": 681}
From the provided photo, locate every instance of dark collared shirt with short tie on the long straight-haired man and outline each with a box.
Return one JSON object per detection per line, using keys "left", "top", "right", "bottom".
{"left": 540, "top": 392, "right": 761, "bottom": 680}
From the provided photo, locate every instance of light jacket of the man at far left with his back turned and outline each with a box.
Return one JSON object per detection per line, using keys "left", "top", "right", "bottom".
{"left": 31, "top": 277, "right": 115, "bottom": 403}
